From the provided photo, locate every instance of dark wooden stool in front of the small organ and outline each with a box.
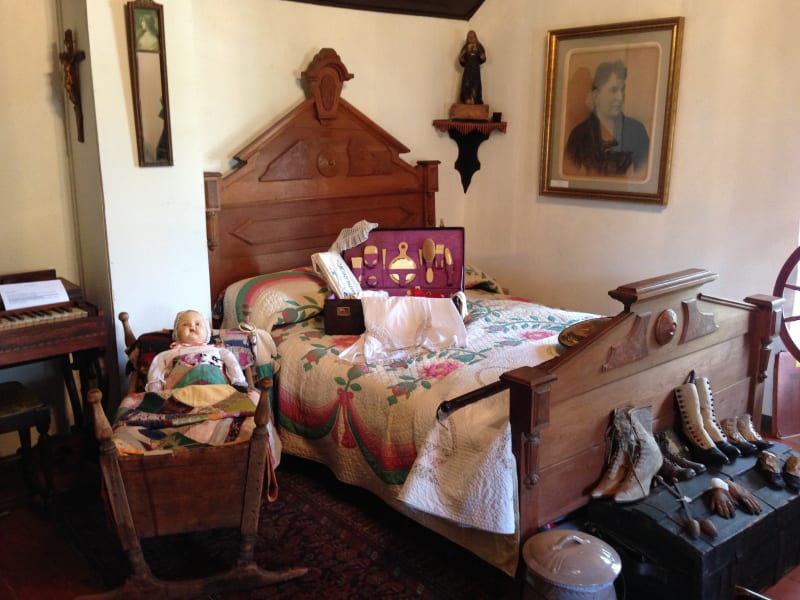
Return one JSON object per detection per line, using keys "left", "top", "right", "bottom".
{"left": 0, "top": 381, "right": 53, "bottom": 503}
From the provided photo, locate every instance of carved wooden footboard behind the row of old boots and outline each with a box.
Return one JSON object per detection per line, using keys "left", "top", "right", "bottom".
{"left": 501, "top": 269, "right": 782, "bottom": 540}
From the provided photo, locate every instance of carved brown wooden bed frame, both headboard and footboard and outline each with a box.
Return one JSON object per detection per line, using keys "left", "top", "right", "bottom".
{"left": 205, "top": 49, "right": 781, "bottom": 576}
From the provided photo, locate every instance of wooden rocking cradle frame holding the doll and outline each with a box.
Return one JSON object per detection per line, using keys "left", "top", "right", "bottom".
{"left": 83, "top": 313, "right": 307, "bottom": 598}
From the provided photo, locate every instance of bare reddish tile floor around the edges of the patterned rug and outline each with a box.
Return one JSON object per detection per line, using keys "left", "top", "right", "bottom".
{"left": 0, "top": 436, "right": 800, "bottom": 600}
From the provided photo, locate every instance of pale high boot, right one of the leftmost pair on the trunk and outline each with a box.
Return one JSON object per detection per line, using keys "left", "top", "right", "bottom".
{"left": 614, "top": 406, "right": 664, "bottom": 503}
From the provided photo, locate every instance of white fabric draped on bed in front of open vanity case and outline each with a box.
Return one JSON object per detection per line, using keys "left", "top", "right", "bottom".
{"left": 339, "top": 296, "right": 467, "bottom": 363}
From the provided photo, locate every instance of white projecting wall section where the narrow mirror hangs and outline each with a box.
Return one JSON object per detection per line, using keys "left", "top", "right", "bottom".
{"left": 86, "top": 0, "right": 210, "bottom": 332}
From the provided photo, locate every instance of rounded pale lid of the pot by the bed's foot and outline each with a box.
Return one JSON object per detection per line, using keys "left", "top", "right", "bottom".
{"left": 522, "top": 529, "right": 622, "bottom": 586}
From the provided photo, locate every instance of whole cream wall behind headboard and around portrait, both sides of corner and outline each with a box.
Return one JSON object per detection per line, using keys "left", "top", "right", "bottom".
{"left": 186, "top": 0, "right": 800, "bottom": 312}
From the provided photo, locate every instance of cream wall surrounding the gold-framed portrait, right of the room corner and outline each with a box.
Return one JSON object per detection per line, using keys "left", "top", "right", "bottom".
{"left": 465, "top": 0, "right": 800, "bottom": 311}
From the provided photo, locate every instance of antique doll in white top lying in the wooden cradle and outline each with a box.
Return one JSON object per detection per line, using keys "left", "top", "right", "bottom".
{"left": 145, "top": 310, "right": 247, "bottom": 392}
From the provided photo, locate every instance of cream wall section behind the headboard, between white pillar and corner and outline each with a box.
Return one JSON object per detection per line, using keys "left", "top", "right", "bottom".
{"left": 192, "top": 0, "right": 468, "bottom": 218}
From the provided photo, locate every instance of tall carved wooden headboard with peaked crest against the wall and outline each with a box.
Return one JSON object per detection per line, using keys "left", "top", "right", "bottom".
{"left": 204, "top": 48, "right": 439, "bottom": 302}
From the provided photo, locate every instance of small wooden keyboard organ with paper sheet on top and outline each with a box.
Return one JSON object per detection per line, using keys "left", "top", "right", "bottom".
{"left": 0, "top": 269, "right": 108, "bottom": 426}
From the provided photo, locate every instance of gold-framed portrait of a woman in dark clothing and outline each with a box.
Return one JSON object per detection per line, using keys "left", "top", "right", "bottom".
{"left": 539, "top": 17, "right": 683, "bottom": 205}
